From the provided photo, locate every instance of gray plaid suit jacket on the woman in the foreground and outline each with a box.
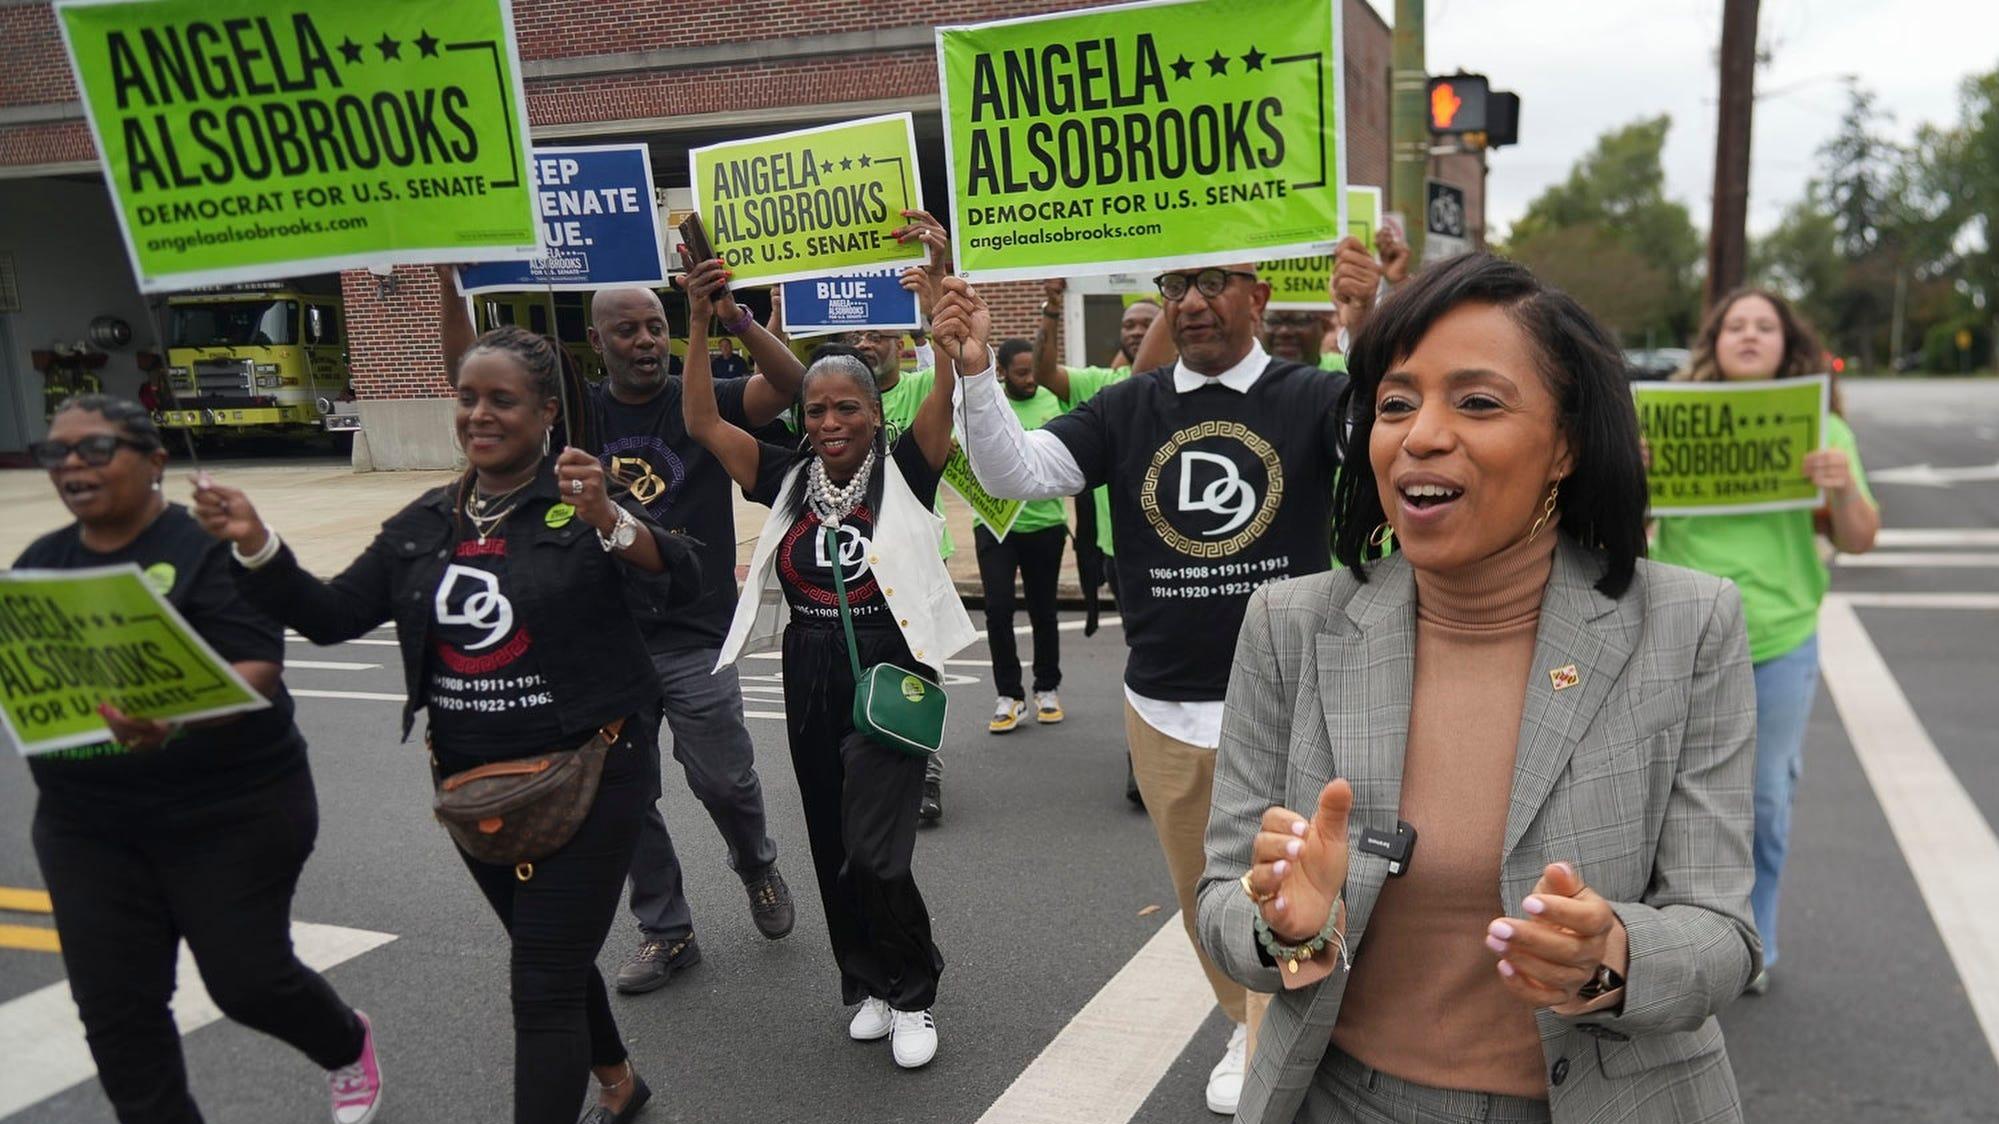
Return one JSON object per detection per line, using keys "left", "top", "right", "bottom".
{"left": 1199, "top": 538, "right": 1761, "bottom": 1124}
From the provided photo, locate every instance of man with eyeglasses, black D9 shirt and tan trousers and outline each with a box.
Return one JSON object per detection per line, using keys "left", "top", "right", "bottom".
{"left": 960, "top": 264, "right": 1347, "bottom": 1114}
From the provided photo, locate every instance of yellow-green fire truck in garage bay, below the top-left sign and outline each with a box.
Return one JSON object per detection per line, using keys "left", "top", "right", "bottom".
{"left": 160, "top": 286, "right": 348, "bottom": 434}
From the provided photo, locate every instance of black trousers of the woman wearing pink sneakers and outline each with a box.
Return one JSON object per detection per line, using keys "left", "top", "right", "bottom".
{"left": 32, "top": 764, "right": 362, "bottom": 1124}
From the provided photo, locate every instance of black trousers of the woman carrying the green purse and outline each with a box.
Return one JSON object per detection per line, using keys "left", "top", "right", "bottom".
{"left": 784, "top": 622, "right": 944, "bottom": 1010}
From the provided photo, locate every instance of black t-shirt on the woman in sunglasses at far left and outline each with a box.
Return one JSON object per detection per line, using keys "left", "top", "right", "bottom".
{"left": 14, "top": 504, "right": 306, "bottom": 808}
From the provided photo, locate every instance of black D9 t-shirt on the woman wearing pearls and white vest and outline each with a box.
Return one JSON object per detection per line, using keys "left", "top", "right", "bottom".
{"left": 746, "top": 436, "right": 938, "bottom": 626}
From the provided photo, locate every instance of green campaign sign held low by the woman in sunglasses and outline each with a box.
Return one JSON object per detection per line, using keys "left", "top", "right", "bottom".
{"left": 0, "top": 564, "right": 270, "bottom": 756}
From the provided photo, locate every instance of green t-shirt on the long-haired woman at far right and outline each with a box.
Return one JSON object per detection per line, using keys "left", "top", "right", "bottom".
{"left": 1651, "top": 414, "right": 1873, "bottom": 664}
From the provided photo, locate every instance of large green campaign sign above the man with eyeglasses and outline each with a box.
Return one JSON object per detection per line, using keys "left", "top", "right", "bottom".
{"left": 938, "top": 0, "right": 1345, "bottom": 280}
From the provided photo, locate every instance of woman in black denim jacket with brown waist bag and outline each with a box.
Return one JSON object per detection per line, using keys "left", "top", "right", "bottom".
{"left": 196, "top": 328, "right": 700, "bottom": 1124}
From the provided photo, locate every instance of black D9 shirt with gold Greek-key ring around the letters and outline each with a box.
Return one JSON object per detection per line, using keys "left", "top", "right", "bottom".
{"left": 1043, "top": 360, "right": 1347, "bottom": 702}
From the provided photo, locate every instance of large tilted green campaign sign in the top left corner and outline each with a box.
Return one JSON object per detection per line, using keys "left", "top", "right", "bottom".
{"left": 56, "top": 0, "right": 542, "bottom": 292}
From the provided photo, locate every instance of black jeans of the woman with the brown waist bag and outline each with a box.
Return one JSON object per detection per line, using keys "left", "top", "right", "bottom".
{"left": 434, "top": 718, "right": 660, "bottom": 1124}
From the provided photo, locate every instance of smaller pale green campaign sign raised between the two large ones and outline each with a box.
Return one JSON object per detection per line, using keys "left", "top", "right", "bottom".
{"left": 688, "top": 114, "right": 928, "bottom": 288}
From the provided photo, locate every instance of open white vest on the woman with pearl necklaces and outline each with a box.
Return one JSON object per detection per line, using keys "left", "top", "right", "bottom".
{"left": 716, "top": 460, "right": 978, "bottom": 674}
